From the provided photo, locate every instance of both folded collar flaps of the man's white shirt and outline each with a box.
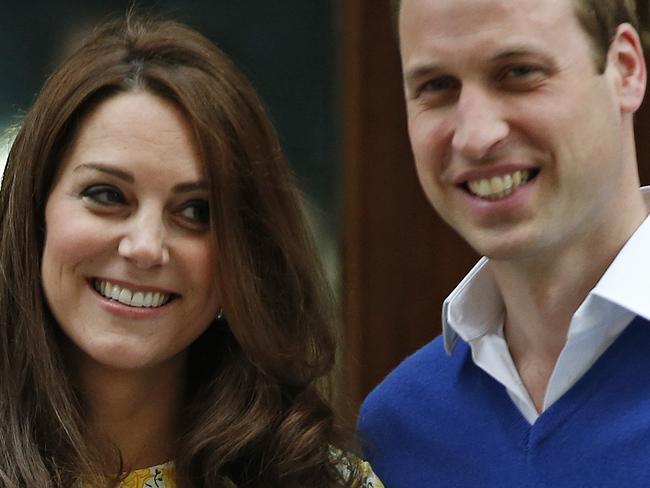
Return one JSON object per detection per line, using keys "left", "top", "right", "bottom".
{"left": 442, "top": 186, "right": 650, "bottom": 355}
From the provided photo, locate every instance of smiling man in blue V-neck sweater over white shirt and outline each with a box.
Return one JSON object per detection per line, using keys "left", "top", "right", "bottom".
{"left": 359, "top": 0, "right": 650, "bottom": 488}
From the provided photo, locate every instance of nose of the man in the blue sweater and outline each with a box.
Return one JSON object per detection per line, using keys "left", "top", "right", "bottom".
{"left": 452, "top": 87, "right": 510, "bottom": 160}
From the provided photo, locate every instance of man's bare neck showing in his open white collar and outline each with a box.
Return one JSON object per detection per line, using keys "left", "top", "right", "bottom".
{"left": 490, "top": 198, "right": 647, "bottom": 412}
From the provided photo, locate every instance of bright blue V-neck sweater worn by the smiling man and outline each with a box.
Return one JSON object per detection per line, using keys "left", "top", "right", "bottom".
{"left": 359, "top": 317, "right": 650, "bottom": 488}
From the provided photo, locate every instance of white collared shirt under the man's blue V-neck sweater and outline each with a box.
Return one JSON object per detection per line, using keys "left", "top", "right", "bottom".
{"left": 442, "top": 186, "right": 650, "bottom": 424}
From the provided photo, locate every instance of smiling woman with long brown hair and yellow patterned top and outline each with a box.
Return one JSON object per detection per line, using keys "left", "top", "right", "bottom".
{"left": 0, "top": 17, "right": 381, "bottom": 488}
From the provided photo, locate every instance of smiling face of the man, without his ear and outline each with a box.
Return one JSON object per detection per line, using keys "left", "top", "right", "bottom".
{"left": 400, "top": 0, "right": 637, "bottom": 259}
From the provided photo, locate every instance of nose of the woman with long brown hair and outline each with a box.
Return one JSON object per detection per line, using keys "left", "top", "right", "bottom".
{"left": 118, "top": 211, "right": 169, "bottom": 269}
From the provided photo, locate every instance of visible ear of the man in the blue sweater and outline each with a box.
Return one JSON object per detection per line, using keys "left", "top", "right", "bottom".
{"left": 607, "top": 24, "right": 647, "bottom": 113}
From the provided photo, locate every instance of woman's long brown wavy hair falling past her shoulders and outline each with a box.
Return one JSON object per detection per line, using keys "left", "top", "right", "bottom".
{"left": 0, "top": 15, "right": 352, "bottom": 488}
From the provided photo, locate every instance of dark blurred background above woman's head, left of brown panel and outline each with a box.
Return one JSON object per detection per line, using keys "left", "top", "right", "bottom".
{"left": 0, "top": 0, "right": 341, "bottom": 244}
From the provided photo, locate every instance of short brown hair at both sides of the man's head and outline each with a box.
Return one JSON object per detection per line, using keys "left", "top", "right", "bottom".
{"left": 390, "top": 0, "right": 639, "bottom": 73}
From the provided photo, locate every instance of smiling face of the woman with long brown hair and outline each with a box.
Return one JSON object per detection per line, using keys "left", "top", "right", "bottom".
{"left": 42, "top": 91, "right": 219, "bottom": 370}
